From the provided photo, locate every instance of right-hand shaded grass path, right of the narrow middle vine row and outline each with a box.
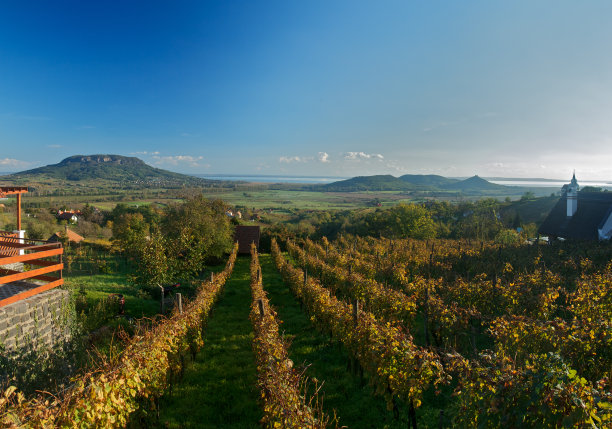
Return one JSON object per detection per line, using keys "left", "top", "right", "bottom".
{"left": 259, "top": 254, "right": 418, "bottom": 429}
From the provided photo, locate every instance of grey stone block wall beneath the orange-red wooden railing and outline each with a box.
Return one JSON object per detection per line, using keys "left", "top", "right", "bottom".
{"left": 0, "top": 288, "right": 71, "bottom": 353}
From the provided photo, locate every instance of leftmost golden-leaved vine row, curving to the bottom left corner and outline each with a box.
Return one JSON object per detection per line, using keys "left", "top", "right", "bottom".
{"left": 0, "top": 245, "right": 238, "bottom": 428}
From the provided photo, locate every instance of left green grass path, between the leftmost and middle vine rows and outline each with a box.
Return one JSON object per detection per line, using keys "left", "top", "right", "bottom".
{"left": 160, "top": 257, "right": 263, "bottom": 428}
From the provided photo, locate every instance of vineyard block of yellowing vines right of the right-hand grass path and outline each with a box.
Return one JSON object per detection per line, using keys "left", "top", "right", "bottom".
{"left": 273, "top": 238, "right": 612, "bottom": 427}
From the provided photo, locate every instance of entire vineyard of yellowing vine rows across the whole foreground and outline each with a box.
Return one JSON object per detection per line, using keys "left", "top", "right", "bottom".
{"left": 0, "top": 237, "right": 612, "bottom": 428}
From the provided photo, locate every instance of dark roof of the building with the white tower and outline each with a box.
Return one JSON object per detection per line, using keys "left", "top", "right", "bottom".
{"left": 539, "top": 192, "right": 612, "bottom": 240}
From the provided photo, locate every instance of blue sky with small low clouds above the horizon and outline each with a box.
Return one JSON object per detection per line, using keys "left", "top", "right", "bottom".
{"left": 0, "top": 0, "right": 612, "bottom": 180}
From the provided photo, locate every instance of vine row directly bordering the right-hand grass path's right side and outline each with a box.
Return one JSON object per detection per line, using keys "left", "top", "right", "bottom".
{"left": 271, "top": 240, "right": 442, "bottom": 415}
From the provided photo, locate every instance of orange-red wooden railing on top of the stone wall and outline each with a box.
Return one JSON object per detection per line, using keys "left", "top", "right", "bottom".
{"left": 0, "top": 236, "right": 64, "bottom": 307}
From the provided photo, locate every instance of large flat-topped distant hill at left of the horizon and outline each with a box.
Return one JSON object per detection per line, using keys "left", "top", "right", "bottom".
{"left": 2, "top": 155, "right": 215, "bottom": 185}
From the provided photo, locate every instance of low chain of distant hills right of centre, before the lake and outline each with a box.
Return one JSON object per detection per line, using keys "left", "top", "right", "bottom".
{"left": 317, "top": 174, "right": 524, "bottom": 195}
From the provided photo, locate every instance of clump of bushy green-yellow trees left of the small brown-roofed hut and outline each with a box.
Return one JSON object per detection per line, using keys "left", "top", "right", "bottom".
{"left": 111, "top": 196, "right": 233, "bottom": 289}
